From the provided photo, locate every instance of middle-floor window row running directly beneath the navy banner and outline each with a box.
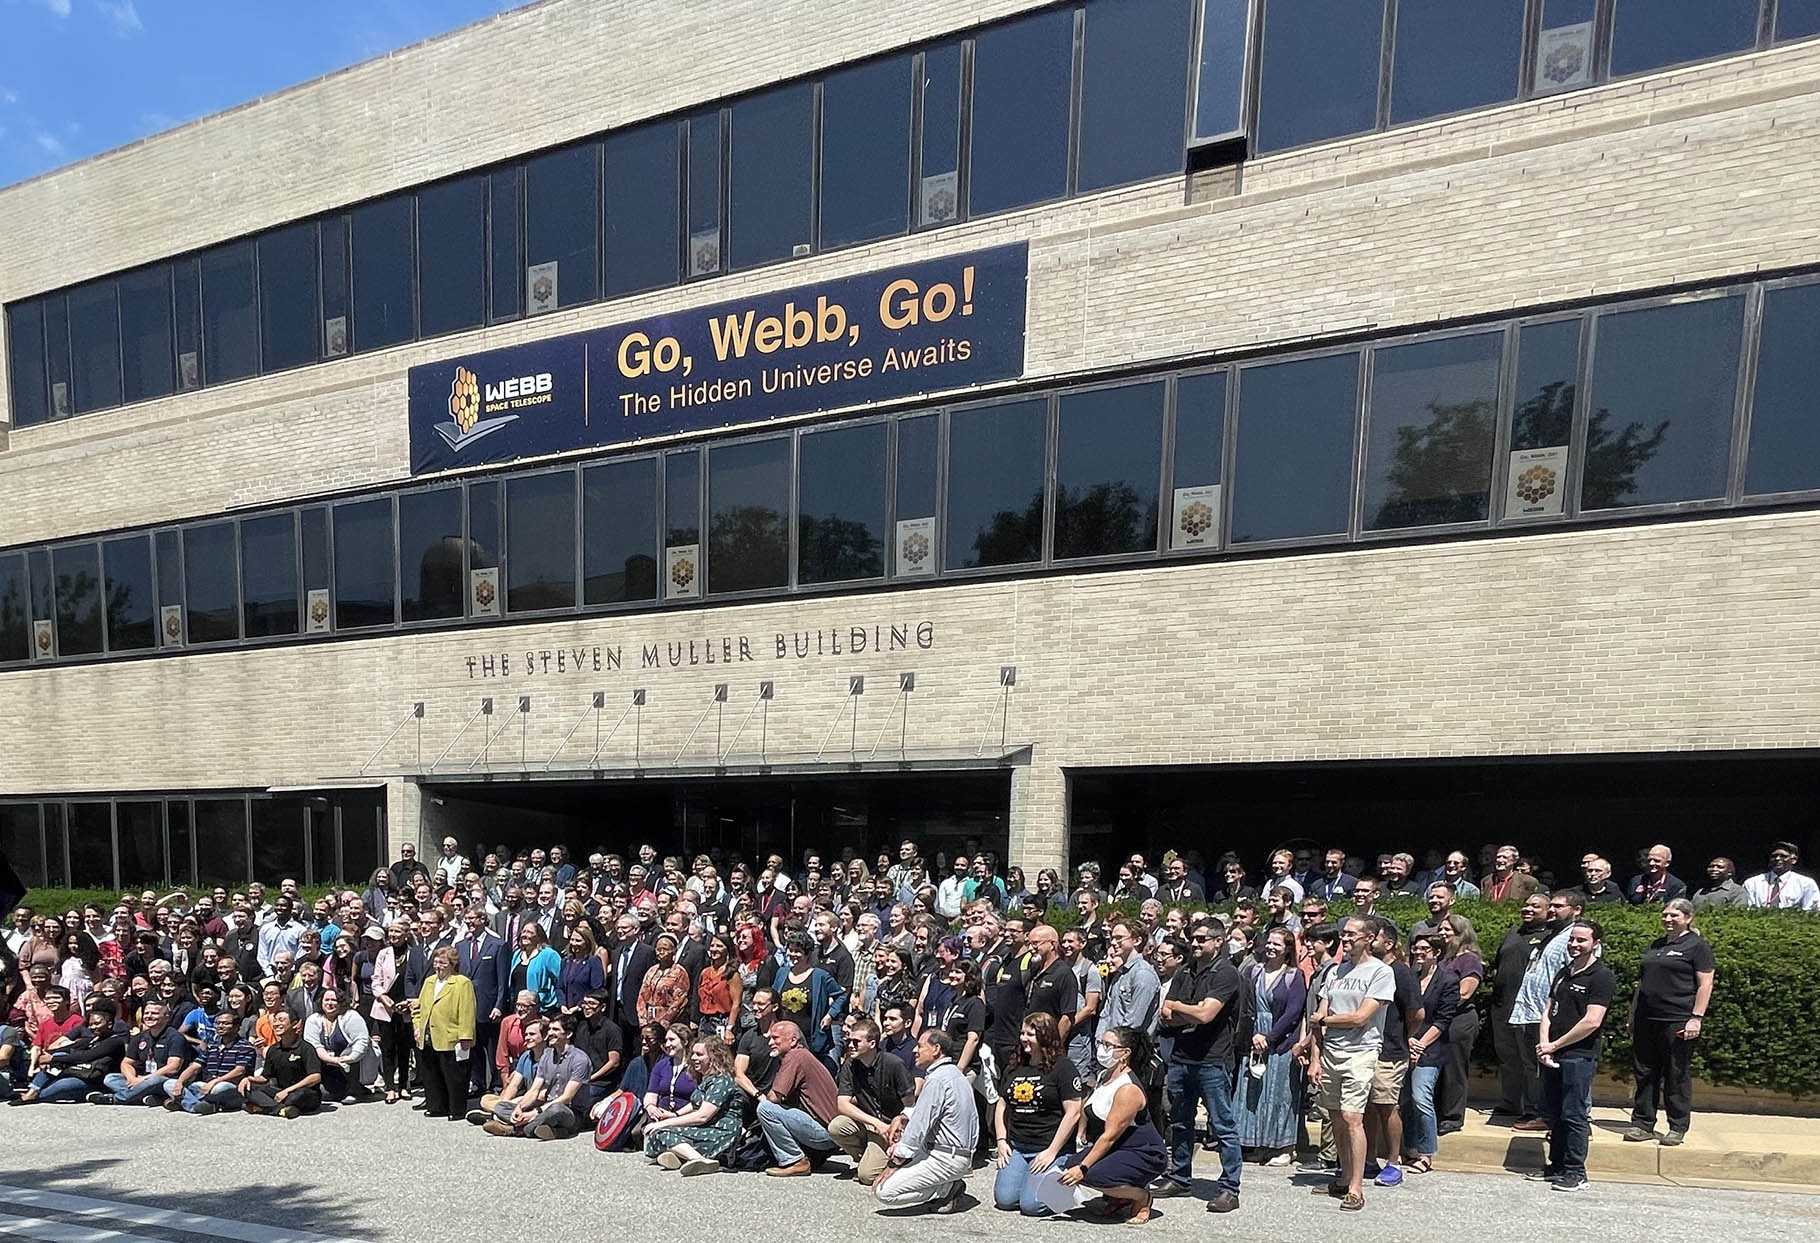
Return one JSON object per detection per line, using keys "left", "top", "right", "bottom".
{"left": 0, "top": 271, "right": 1820, "bottom": 662}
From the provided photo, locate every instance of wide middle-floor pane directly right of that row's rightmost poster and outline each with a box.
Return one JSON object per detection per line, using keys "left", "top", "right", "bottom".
{"left": 1580, "top": 297, "right": 1744, "bottom": 510}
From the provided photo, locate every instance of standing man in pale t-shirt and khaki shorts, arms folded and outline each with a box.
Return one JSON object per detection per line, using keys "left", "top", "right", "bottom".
{"left": 1309, "top": 915, "right": 1396, "bottom": 1212}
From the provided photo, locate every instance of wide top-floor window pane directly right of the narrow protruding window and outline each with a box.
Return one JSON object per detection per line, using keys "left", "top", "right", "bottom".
{"left": 1258, "top": 0, "right": 1383, "bottom": 151}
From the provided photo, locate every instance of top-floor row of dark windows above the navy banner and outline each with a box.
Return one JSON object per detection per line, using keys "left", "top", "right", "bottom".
{"left": 7, "top": 0, "right": 1820, "bottom": 426}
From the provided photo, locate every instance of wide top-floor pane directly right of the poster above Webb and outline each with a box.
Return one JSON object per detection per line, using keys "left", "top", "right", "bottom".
{"left": 726, "top": 82, "right": 815, "bottom": 269}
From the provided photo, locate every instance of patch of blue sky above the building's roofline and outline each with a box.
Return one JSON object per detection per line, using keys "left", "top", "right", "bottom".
{"left": 0, "top": 0, "right": 526, "bottom": 186}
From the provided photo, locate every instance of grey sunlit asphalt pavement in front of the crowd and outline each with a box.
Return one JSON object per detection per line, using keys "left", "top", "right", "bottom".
{"left": 0, "top": 1105, "right": 1820, "bottom": 1243}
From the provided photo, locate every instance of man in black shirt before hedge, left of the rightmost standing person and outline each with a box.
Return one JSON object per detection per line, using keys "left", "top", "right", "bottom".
{"left": 1531, "top": 919, "right": 1618, "bottom": 1192}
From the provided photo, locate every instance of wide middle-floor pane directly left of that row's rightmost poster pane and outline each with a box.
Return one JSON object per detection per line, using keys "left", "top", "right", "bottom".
{"left": 1363, "top": 333, "right": 1503, "bottom": 531}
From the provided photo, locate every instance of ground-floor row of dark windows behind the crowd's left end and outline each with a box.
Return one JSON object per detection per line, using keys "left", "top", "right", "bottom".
{"left": 0, "top": 788, "right": 386, "bottom": 890}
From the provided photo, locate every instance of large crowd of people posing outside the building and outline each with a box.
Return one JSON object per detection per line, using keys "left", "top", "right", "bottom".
{"left": 0, "top": 839, "right": 1798, "bottom": 1223}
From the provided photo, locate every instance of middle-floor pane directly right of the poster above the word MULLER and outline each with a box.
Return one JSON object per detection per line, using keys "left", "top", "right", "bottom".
{"left": 708, "top": 437, "right": 790, "bottom": 593}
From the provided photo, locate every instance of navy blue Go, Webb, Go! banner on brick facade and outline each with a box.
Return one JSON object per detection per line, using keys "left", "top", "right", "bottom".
{"left": 410, "top": 244, "right": 1028, "bottom": 475}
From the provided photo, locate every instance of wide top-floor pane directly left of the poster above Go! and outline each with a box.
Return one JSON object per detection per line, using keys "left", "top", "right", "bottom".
{"left": 821, "top": 56, "right": 910, "bottom": 248}
